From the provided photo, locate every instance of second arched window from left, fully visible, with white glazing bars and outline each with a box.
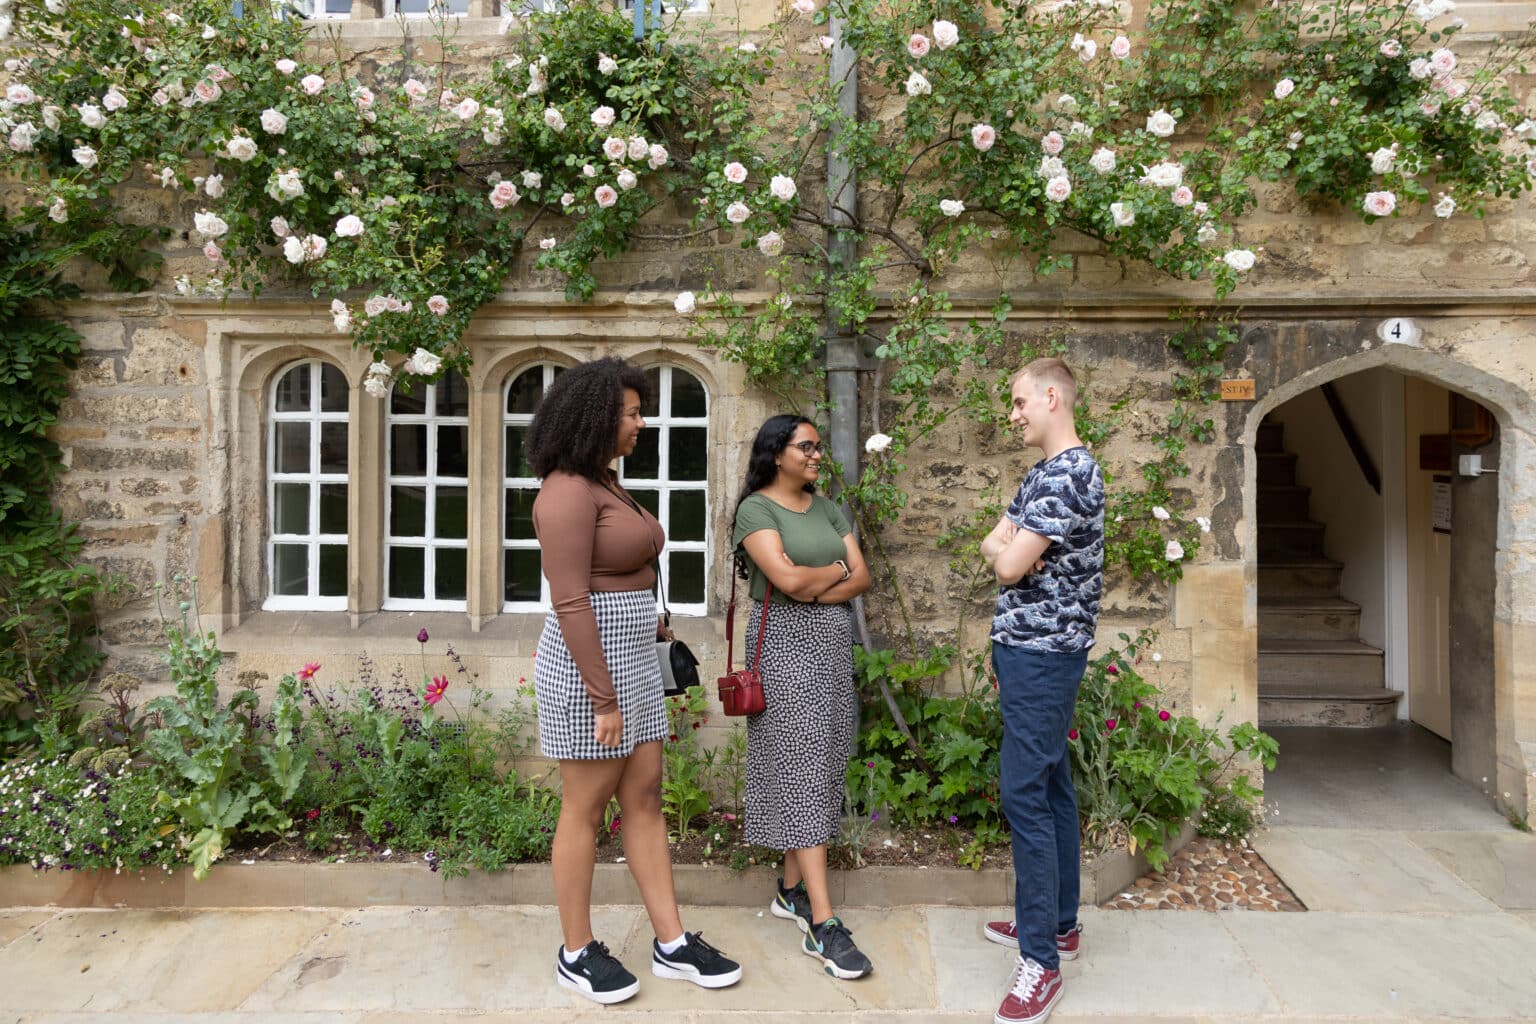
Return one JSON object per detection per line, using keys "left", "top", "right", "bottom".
{"left": 384, "top": 370, "right": 470, "bottom": 611}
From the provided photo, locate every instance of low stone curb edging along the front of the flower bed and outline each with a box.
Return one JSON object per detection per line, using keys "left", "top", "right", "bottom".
{"left": 0, "top": 826, "right": 1193, "bottom": 910}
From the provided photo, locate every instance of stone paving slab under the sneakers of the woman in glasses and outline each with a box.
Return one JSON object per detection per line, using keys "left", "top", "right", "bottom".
{"left": 617, "top": 907, "right": 934, "bottom": 1013}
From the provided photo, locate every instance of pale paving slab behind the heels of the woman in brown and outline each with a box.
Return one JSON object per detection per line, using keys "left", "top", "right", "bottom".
{"left": 240, "top": 907, "right": 636, "bottom": 1013}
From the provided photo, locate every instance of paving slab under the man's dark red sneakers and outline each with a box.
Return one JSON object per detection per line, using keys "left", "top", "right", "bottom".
{"left": 925, "top": 907, "right": 1281, "bottom": 1021}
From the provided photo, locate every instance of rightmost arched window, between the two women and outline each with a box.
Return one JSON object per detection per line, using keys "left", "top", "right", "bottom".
{"left": 619, "top": 365, "right": 710, "bottom": 616}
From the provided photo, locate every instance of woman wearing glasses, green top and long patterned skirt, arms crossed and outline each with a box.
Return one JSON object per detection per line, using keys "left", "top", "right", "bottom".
{"left": 733, "top": 416, "right": 871, "bottom": 978}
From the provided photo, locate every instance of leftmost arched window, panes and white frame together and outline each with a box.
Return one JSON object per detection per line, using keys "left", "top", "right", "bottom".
{"left": 264, "top": 359, "right": 349, "bottom": 611}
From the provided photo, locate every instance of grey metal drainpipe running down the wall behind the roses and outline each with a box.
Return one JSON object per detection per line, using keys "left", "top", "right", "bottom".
{"left": 823, "top": 15, "right": 869, "bottom": 648}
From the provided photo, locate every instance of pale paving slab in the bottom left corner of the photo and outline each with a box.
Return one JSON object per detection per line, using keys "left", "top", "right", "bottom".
{"left": 0, "top": 910, "right": 336, "bottom": 1013}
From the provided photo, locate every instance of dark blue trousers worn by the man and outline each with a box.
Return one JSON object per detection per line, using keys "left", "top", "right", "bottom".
{"left": 992, "top": 642, "right": 1087, "bottom": 970}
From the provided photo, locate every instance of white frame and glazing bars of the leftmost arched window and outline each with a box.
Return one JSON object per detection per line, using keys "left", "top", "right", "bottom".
{"left": 261, "top": 359, "right": 352, "bottom": 611}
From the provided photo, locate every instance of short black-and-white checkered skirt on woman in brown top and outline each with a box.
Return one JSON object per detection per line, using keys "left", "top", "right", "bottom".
{"left": 533, "top": 590, "right": 667, "bottom": 760}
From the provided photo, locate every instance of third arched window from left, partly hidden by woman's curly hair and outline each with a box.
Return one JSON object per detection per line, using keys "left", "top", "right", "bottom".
{"left": 501, "top": 362, "right": 561, "bottom": 611}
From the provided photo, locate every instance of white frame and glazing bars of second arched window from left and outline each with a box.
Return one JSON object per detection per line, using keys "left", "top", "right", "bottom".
{"left": 379, "top": 374, "right": 473, "bottom": 611}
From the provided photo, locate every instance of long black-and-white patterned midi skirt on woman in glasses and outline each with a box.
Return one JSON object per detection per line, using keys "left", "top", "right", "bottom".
{"left": 746, "top": 602, "right": 859, "bottom": 851}
